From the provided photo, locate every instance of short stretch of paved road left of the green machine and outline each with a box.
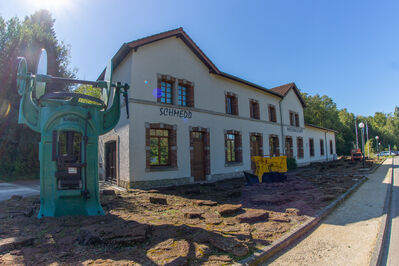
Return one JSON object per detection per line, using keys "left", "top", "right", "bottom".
{"left": 0, "top": 181, "right": 40, "bottom": 201}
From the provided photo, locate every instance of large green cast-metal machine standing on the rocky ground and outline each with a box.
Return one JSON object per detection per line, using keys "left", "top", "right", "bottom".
{"left": 17, "top": 49, "right": 129, "bottom": 218}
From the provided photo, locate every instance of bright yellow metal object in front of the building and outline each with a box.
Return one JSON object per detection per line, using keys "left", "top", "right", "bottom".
{"left": 251, "top": 156, "right": 287, "bottom": 183}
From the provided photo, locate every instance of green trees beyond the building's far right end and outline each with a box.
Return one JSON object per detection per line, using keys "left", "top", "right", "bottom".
{"left": 302, "top": 93, "right": 399, "bottom": 154}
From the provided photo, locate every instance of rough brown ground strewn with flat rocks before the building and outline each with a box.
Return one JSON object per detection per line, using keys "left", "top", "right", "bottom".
{"left": 0, "top": 157, "right": 382, "bottom": 265}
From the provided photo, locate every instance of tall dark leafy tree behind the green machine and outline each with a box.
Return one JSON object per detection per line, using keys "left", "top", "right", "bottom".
{"left": 0, "top": 10, "right": 74, "bottom": 176}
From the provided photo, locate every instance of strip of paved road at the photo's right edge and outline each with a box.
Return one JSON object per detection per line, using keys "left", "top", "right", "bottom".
{"left": 382, "top": 158, "right": 399, "bottom": 266}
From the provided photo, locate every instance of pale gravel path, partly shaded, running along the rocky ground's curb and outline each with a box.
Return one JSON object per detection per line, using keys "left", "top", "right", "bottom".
{"left": 265, "top": 159, "right": 392, "bottom": 266}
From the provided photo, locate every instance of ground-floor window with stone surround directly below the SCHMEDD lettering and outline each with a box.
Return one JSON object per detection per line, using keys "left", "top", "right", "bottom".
{"left": 146, "top": 123, "right": 177, "bottom": 169}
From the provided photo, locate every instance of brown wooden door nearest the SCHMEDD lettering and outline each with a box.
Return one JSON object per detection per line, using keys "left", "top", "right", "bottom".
{"left": 191, "top": 131, "right": 206, "bottom": 181}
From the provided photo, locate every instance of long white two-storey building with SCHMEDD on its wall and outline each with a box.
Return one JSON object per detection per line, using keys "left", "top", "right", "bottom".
{"left": 99, "top": 28, "right": 336, "bottom": 187}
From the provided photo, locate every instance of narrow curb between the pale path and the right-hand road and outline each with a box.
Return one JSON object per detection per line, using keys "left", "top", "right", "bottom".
{"left": 370, "top": 158, "right": 394, "bottom": 266}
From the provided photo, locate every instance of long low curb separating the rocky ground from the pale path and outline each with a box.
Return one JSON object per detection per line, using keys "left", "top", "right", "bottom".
{"left": 238, "top": 162, "right": 383, "bottom": 265}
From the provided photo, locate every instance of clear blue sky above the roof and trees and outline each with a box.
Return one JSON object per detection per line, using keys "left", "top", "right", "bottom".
{"left": 0, "top": 0, "right": 399, "bottom": 116}
